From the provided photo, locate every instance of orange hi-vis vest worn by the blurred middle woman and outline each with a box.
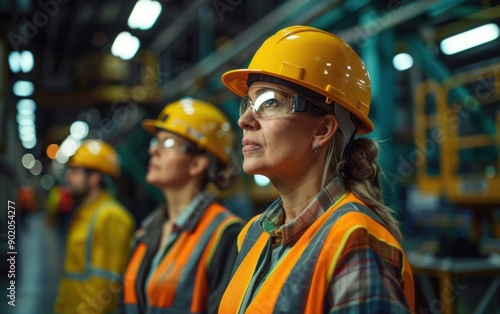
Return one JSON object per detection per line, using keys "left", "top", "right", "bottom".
{"left": 123, "top": 203, "right": 241, "bottom": 314}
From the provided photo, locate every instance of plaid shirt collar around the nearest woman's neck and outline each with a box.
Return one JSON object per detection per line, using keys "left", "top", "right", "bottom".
{"left": 259, "top": 178, "right": 347, "bottom": 245}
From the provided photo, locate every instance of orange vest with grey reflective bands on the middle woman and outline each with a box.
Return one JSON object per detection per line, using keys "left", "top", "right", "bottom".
{"left": 123, "top": 203, "right": 242, "bottom": 314}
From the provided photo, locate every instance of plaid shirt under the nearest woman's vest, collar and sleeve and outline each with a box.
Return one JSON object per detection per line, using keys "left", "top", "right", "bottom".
{"left": 252, "top": 179, "right": 412, "bottom": 313}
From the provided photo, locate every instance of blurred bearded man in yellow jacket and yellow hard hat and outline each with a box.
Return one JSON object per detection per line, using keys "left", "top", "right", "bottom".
{"left": 55, "top": 140, "right": 135, "bottom": 314}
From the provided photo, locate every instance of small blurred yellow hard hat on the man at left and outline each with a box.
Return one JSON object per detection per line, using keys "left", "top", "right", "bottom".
{"left": 68, "top": 140, "right": 120, "bottom": 177}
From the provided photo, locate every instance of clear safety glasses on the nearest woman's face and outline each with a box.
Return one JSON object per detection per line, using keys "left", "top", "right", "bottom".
{"left": 240, "top": 87, "right": 325, "bottom": 119}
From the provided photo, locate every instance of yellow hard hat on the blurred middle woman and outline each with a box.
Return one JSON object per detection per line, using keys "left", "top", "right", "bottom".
{"left": 142, "top": 98, "right": 234, "bottom": 163}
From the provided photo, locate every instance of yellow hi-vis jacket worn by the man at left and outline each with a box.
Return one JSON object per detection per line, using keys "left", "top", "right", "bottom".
{"left": 54, "top": 193, "right": 135, "bottom": 314}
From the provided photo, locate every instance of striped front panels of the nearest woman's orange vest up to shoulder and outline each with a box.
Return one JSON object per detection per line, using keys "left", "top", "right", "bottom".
{"left": 220, "top": 194, "right": 408, "bottom": 313}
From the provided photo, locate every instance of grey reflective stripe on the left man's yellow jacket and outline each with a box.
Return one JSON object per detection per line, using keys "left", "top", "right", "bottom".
{"left": 64, "top": 201, "right": 121, "bottom": 281}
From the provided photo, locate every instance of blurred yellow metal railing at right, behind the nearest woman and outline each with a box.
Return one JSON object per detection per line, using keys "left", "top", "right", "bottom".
{"left": 415, "top": 64, "right": 500, "bottom": 205}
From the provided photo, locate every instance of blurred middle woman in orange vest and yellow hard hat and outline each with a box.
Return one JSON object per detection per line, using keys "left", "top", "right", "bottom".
{"left": 124, "top": 98, "right": 242, "bottom": 313}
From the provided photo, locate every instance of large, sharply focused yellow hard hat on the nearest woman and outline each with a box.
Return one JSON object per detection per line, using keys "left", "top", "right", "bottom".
{"left": 222, "top": 26, "right": 374, "bottom": 134}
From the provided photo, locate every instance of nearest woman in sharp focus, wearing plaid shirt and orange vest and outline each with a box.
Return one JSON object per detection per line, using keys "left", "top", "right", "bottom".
{"left": 219, "top": 26, "right": 414, "bottom": 314}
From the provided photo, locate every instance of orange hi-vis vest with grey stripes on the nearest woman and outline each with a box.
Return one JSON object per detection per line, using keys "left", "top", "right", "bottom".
{"left": 219, "top": 194, "right": 414, "bottom": 314}
